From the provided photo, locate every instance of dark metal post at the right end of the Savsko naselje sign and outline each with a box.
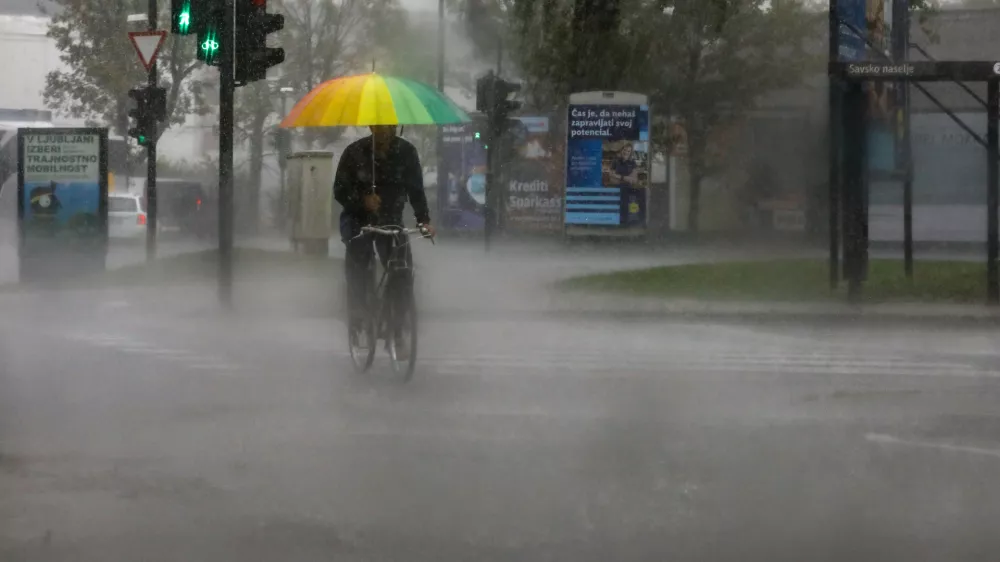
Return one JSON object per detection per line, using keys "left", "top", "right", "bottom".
{"left": 986, "top": 79, "right": 1000, "bottom": 306}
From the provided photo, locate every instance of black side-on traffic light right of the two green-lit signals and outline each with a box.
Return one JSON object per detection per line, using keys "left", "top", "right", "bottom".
{"left": 236, "top": 0, "right": 285, "bottom": 86}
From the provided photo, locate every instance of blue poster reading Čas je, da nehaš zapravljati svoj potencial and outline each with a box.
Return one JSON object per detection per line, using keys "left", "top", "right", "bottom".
{"left": 564, "top": 105, "right": 649, "bottom": 227}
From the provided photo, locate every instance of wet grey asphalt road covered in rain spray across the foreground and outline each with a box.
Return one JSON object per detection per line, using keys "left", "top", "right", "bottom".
{"left": 0, "top": 240, "right": 1000, "bottom": 562}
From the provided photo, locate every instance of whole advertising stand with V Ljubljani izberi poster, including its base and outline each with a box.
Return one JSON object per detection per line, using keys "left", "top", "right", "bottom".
{"left": 17, "top": 128, "right": 108, "bottom": 281}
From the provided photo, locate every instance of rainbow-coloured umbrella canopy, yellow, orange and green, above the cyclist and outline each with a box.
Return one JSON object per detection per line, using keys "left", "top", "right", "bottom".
{"left": 281, "top": 72, "right": 471, "bottom": 128}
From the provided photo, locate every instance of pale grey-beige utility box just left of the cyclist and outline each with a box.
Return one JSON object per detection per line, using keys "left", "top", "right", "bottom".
{"left": 288, "top": 150, "right": 334, "bottom": 255}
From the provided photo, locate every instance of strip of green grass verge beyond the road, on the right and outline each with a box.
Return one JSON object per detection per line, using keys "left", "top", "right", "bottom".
{"left": 557, "top": 259, "right": 986, "bottom": 303}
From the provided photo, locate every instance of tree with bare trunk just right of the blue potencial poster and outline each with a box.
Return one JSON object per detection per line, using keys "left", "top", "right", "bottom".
{"left": 647, "top": 0, "right": 825, "bottom": 232}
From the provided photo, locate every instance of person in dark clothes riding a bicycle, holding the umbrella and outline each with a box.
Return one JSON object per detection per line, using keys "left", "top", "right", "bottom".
{"left": 333, "top": 125, "right": 434, "bottom": 356}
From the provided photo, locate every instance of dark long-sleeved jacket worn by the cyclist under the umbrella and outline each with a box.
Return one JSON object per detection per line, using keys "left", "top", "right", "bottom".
{"left": 333, "top": 136, "right": 430, "bottom": 225}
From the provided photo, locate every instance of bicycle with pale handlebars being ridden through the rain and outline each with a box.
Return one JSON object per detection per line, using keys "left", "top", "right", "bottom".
{"left": 348, "top": 225, "right": 434, "bottom": 381}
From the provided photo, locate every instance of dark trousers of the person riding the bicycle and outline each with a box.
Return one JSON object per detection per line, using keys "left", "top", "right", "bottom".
{"left": 344, "top": 229, "right": 413, "bottom": 321}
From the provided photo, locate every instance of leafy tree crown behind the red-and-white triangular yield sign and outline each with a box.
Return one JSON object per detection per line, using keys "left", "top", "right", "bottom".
{"left": 43, "top": 0, "right": 203, "bottom": 139}
